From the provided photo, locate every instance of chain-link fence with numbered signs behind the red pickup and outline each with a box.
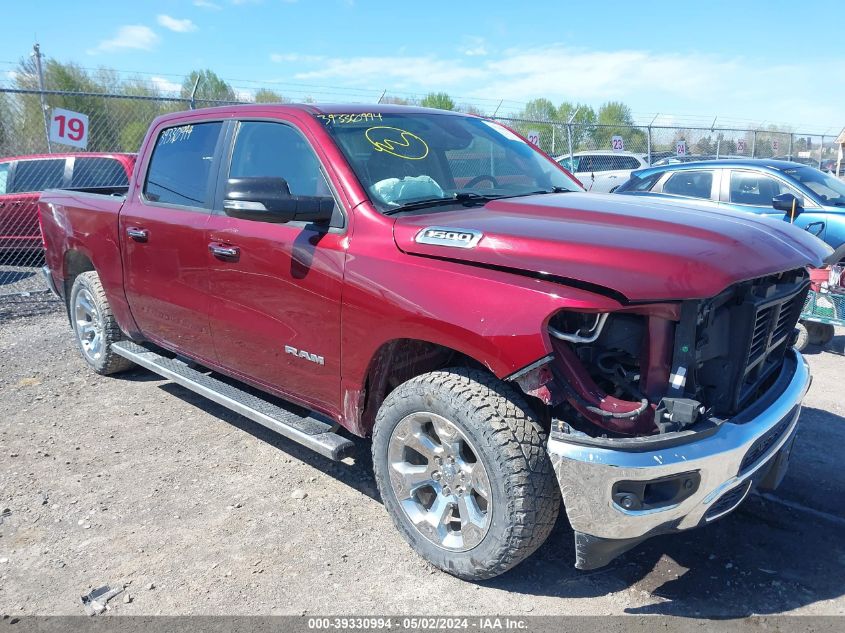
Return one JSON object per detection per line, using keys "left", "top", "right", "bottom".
{"left": 0, "top": 89, "right": 836, "bottom": 318}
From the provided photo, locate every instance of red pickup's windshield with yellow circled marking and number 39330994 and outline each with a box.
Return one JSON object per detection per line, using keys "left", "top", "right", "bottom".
{"left": 315, "top": 113, "right": 580, "bottom": 212}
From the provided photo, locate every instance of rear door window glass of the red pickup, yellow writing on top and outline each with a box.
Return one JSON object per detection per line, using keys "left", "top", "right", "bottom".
{"left": 144, "top": 121, "right": 223, "bottom": 208}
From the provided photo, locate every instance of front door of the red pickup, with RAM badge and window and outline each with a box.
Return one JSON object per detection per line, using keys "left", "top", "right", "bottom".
{"left": 206, "top": 121, "right": 346, "bottom": 413}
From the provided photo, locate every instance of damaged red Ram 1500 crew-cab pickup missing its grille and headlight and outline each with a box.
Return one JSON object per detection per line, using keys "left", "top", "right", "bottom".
{"left": 40, "top": 105, "right": 828, "bottom": 578}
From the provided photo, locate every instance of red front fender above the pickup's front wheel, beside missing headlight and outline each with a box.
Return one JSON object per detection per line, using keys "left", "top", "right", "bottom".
{"left": 341, "top": 244, "right": 621, "bottom": 428}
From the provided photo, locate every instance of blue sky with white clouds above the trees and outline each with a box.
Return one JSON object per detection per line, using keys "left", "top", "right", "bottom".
{"left": 0, "top": 0, "right": 845, "bottom": 134}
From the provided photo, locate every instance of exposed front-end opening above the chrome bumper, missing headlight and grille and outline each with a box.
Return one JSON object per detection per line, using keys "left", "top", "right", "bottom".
{"left": 516, "top": 269, "right": 809, "bottom": 438}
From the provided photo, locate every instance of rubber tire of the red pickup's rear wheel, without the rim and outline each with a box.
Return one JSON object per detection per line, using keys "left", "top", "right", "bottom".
{"left": 68, "top": 271, "right": 135, "bottom": 376}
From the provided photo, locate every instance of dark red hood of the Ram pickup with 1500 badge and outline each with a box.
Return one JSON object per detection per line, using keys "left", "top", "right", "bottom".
{"left": 394, "top": 193, "right": 830, "bottom": 301}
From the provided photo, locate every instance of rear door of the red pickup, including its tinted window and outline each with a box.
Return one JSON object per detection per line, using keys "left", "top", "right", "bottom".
{"left": 120, "top": 120, "right": 224, "bottom": 361}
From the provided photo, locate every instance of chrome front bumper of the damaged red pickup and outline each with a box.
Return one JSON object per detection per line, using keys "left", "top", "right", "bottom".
{"left": 548, "top": 350, "right": 811, "bottom": 569}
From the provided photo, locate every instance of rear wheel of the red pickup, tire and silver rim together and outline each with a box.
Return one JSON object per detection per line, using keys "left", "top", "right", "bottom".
{"left": 68, "top": 271, "right": 133, "bottom": 375}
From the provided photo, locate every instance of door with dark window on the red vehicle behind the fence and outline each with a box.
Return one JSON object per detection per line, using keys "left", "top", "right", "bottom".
{"left": 0, "top": 157, "right": 67, "bottom": 250}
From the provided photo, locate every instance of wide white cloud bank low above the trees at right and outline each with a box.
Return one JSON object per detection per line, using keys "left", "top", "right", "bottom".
{"left": 284, "top": 44, "right": 845, "bottom": 129}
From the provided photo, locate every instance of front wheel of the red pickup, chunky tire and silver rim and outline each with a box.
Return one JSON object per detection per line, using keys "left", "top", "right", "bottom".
{"left": 373, "top": 369, "right": 560, "bottom": 580}
